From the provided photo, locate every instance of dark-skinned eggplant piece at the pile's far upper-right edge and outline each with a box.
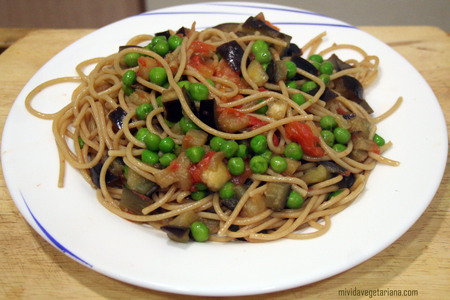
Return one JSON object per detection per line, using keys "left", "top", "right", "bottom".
{"left": 333, "top": 75, "right": 373, "bottom": 114}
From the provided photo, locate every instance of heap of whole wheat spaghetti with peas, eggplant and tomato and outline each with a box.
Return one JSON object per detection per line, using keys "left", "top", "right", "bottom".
{"left": 25, "top": 14, "right": 402, "bottom": 242}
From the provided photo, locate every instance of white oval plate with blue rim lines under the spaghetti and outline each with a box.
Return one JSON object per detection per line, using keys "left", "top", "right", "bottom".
{"left": 2, "top": 2, "right": 447, "bottom": 296}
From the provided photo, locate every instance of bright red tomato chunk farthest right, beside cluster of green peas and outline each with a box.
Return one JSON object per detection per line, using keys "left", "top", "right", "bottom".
{"left": 284, "top": 122, "right": 325, "bottom": 156}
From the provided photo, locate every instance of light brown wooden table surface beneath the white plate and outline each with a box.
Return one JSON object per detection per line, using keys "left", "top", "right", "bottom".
{"left": 0, "top": 26, "right": 450, "bottom": 299}
